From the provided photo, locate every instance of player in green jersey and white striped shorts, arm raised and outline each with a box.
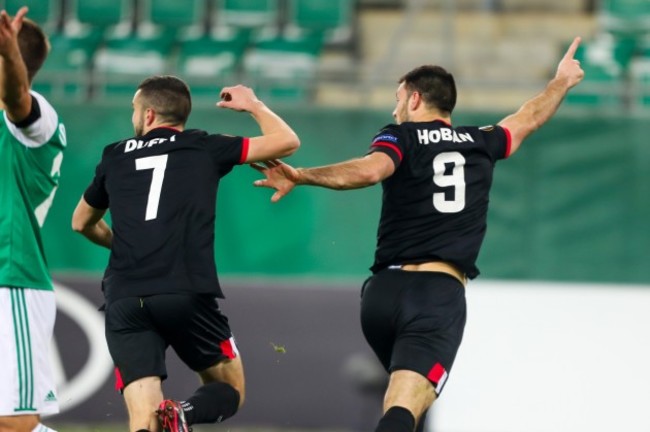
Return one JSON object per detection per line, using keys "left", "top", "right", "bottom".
{"left": 0, "top": 7, "right": 66, "bottom": 431}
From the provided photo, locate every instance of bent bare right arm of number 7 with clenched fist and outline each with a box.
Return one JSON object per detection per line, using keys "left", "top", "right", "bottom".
{"left": 217, "top": 85, "right": 300, "bottom": 163}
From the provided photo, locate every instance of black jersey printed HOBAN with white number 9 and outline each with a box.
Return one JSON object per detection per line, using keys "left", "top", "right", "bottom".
{"left": 370, "top": 120, "right": 510, "bottom": 278}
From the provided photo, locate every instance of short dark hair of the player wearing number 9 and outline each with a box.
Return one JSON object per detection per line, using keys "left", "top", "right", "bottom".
{"left": 398, "top": 65, "right": 456, "bottom": 114}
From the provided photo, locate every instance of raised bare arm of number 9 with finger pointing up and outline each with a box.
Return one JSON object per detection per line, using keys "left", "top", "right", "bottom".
{"left": 499, "top": 37, "right": 585, "bottom": 154}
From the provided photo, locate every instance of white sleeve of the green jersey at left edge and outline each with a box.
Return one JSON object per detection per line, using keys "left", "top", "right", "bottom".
{"left": 3, "top": 91, "right": 59, "bottom": 148}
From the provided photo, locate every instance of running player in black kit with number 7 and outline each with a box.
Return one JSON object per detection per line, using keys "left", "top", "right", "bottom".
{"left": 72, "top": 76, "right": 300, "bottom": 432}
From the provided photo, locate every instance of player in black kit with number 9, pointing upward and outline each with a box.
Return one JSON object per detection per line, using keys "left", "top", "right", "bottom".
{"left": 253, "top": 38, "right": 584, "bottom": 432}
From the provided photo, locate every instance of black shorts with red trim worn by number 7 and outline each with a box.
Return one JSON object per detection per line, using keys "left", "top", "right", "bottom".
{"left": 106, "top": 294, "right": 237, "bottom": 390}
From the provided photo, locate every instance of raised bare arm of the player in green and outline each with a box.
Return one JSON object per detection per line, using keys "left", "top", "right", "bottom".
{"left": 0, "top": 7, "right": 32, "bottom": 123}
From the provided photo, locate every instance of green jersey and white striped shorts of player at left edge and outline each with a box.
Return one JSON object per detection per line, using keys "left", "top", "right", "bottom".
{"left": 0, "top": 91, "right": 66, "bottom": 415}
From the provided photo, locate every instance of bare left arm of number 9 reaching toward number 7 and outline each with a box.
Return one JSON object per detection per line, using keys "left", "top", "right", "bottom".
{"left": 251, "top": 152, "right": 395, "bottom": 202}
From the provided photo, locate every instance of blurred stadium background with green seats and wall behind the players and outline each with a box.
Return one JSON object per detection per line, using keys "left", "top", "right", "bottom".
{"left": 10, "top": 0, "right": 650, "bottom": 432}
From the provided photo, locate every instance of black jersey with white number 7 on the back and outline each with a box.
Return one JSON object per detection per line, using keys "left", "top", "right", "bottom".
{"left": 84, "top": 128, "right": 248, "bottom": 301}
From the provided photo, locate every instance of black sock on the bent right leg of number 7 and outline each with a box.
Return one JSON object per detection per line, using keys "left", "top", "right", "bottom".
{"left": 181, "top": 382, "right": 239, "bottom": 425}
